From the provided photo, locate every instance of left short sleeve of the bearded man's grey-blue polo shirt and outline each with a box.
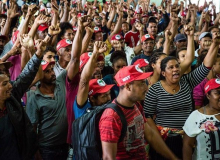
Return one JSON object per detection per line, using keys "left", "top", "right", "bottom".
{"left": 26, "top": 91, "right": 39, "bottom": 124}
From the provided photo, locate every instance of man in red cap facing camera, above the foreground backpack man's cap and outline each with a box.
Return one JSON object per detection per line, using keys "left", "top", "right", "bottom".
{"left": 131, "top": 34, "right": 155, "bottom": 64}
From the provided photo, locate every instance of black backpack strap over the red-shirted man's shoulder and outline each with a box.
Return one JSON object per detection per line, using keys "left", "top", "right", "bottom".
{"left": 106, "top": 103, "right": 127, "bottom": 142}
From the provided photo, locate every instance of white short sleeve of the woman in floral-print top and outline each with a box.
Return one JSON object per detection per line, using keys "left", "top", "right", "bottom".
{"left": 183, "top": 110, "right": 202, "bottom": 137}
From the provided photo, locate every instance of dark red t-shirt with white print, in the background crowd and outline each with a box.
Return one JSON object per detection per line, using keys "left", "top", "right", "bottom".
{"left": 124, "top": 31, "right": 140, "bottom": 48}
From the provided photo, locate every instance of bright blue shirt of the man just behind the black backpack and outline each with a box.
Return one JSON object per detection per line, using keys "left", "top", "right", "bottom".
{"left": 73, "top": 98, "right": 92, "bottom": 119}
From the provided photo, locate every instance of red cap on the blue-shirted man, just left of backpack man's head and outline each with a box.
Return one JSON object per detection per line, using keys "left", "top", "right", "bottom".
{"left": 89, "top": 79, "right": 114, "bottom": 96}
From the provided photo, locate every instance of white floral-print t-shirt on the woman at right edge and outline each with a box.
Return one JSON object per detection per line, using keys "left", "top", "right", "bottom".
{"left": 183, "top": 110, "right": 220, "bottom": 160}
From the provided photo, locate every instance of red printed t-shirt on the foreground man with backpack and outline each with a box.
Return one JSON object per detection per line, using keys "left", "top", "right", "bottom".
{"left": 99, "top": 100, "right": 147, "bottom": 160}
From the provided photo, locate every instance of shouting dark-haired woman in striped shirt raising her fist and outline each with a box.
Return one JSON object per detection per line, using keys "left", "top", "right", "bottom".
{"left": 144, "top": 34, "right": 220, "bottom": 160}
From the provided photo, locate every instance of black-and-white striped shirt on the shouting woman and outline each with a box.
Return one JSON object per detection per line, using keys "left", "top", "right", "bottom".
{"left": 144, "top": 64, "right": 209, "bottom": 129}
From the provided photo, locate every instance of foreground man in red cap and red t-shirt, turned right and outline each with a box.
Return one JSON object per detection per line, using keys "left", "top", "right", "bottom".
{"left": 99, "top": 65, "right": 177, "bottom": 160}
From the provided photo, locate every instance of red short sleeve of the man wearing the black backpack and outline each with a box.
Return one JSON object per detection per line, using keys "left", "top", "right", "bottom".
{"left": 99, "top": 108, "right": 122, "bottom": 143}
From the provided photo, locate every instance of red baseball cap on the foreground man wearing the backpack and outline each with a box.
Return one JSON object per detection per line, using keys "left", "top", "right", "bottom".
{"left": 115, "top": 65, "right": 153, "bottom": 86}
